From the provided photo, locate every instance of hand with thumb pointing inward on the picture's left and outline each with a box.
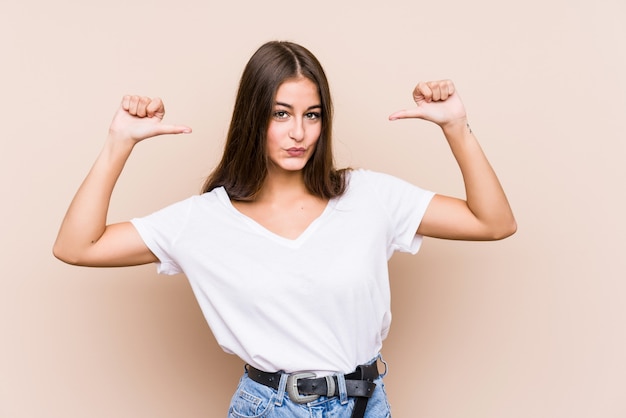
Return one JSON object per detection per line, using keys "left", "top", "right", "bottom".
{"left": 109, "top": 95, "right": 191, "bottom": 143}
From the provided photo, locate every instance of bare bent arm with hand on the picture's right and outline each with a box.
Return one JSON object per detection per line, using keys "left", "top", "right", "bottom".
{"left": 389, "top": 80, "right": 517, "bottom": 241}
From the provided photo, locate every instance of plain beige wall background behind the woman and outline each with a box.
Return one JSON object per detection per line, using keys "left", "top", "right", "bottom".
{"left": 0, "top": 0, "right": 626, "bottom": 418}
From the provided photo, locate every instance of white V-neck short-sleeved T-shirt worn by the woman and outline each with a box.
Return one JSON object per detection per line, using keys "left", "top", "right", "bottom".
{"left": 132, "top": 170, "right": 433, "bottom": 375}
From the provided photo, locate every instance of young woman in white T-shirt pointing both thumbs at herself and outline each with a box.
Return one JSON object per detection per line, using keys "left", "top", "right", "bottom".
{"left": 54, "top": 42, "right": 516, "bottom": 417}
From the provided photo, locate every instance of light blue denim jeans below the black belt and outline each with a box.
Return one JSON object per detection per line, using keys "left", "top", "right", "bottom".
{"left": 228, "top": 357, "right": 391, "bottom": 418}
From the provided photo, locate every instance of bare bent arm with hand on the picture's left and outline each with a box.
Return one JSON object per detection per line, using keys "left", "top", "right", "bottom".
{"left": 53, "top": 96, "right": 191, "bottom": 267}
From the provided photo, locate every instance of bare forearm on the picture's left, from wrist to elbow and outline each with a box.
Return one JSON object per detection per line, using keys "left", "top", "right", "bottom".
{"left": 54, "top": 135, "right": 133, "bottom": 263}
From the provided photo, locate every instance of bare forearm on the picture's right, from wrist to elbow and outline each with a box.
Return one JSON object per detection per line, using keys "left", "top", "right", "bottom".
{"left": 442, "top": 120, "right": 516, "bottom": 238}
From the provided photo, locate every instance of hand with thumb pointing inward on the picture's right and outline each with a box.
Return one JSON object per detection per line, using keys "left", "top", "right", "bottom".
{"left": 389, "top": 80, "right": 467, "bottom": 128}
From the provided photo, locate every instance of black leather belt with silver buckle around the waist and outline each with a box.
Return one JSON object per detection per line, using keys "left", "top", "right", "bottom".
{"left": 246, "top": 362, "right": 379, "bottom": 418}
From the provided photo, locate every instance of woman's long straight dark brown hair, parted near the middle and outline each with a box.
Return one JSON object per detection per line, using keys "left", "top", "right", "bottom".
{"left": 202, "top": 41, "right": 346, "bottom": 200}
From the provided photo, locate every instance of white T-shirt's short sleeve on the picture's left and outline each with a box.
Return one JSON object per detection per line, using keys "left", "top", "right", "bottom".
{"left": 130, "top": 198, "right": 191, "bottom": 275}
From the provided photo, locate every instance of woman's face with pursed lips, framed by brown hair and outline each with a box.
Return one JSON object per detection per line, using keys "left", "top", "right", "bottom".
{"left": 267, "top": 77, "right": 322, "bottom": 172}
